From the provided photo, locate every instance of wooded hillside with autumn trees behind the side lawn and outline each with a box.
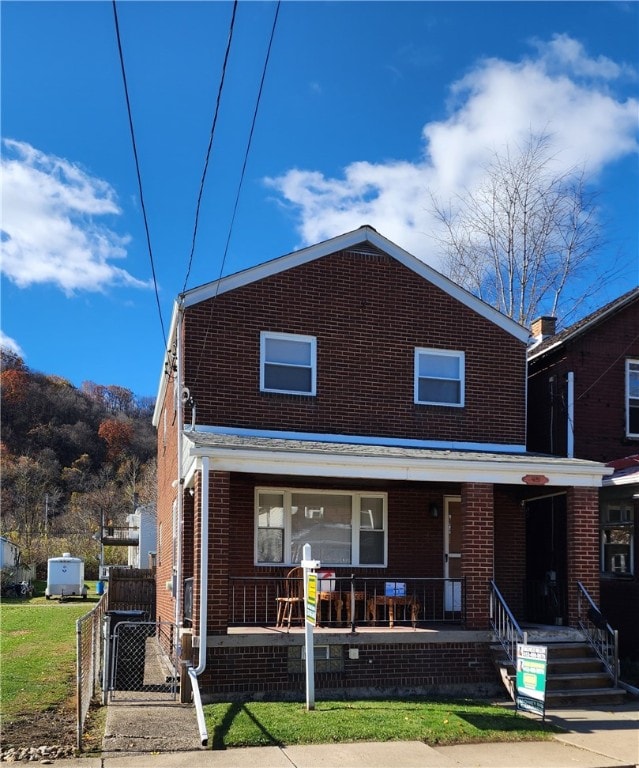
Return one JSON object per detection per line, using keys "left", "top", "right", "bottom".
{"left": 0, "top": 349, "right": 156, "bottom": 578}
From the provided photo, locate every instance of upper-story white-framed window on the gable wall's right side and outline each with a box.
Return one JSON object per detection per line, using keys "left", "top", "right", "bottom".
{"left": 415, "top": 348, "right": 464, "bottom": 407}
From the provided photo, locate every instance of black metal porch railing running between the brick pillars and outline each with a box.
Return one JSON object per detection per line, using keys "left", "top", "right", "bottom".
{"left": 229, "top": 575, "right": 466, "bottom": 631}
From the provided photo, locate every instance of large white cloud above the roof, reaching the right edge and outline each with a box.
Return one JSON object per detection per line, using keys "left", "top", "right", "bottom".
{"left": 266, "top": 35, "right": 639, "bottom": 267}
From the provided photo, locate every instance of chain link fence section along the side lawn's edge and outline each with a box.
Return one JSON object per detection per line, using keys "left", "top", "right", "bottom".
{"left": 75, "top": 595, "right": 106, "bottom": 751}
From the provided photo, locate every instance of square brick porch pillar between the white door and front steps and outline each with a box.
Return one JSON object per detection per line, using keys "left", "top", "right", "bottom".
{"left": 461, "top": 483, "right": 495, "bottom": 629}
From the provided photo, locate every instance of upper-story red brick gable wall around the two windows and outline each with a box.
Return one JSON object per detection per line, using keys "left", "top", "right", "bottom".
{"left": 185, "top": 252, "right": 525, "bottom": 444}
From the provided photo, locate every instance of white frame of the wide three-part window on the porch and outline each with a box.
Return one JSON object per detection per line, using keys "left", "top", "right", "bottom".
{"left": 253, "top": 487, "right": 388, "bottom": 568}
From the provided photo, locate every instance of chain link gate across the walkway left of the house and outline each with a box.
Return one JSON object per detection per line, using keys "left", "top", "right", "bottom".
{"left": 103, "top": 611, "right": 179, "bottom": 703}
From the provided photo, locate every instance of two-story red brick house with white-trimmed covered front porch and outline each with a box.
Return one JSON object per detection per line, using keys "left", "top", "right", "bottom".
{"left": 154, "top": 227, "right": 609, "bottom": 698}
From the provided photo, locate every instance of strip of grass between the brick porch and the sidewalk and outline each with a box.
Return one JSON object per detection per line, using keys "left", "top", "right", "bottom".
{"left": 204, "top": 699, "right": 557, "bottom": 749}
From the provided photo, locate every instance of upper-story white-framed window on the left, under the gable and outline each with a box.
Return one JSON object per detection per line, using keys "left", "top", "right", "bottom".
{"left": 260, "top": 331, "right": 317, "bottom": 395}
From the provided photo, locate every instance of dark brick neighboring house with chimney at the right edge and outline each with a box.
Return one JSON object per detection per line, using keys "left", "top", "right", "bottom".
{"left": 528, "top": 288, "right": 639, "bottom": 656}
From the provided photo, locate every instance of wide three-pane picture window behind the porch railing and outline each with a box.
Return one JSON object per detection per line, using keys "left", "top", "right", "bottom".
{"left": 255, "top": 489, "right": 387, "bottom": 566}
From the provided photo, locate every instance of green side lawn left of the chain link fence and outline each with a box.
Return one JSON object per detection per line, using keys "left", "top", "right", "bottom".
{"left": 0, "top": 582, "right": 98, "bottom": 724}
